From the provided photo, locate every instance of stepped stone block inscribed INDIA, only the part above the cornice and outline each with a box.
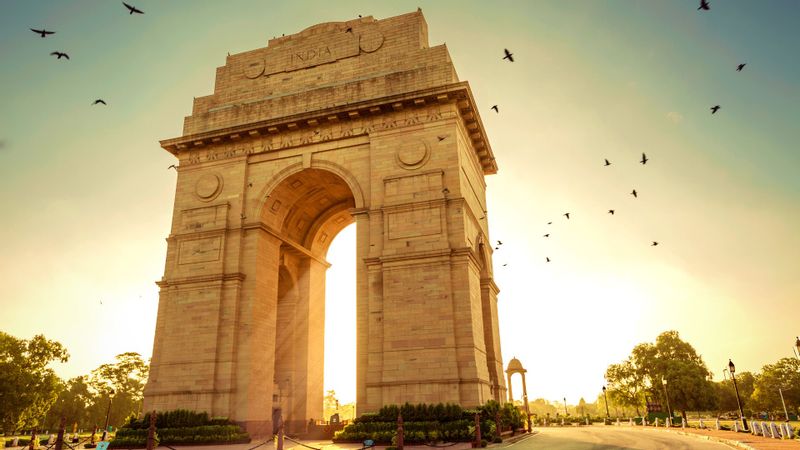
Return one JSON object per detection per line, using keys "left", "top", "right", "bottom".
{"left": 183, "top": 10, "right": 458, "bottom": 135}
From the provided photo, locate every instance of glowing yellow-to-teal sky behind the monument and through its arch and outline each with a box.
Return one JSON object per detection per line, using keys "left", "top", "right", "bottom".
{"left": 0, "top": 0, "right": 800, "bottom": 403}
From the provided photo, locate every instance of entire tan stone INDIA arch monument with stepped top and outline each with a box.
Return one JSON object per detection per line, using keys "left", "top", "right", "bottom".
{"left": 144, "top": 11, "right": 506, "bottom": 435}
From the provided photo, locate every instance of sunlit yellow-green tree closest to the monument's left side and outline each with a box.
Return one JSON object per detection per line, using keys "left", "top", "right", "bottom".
{"left": 88, "top": 352, "right": 149, "bottom": 427}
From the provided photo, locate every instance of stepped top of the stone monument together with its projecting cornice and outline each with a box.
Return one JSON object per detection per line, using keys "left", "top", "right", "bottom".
{"left": 161, "top": 10, "right": 497, "bottom": 174}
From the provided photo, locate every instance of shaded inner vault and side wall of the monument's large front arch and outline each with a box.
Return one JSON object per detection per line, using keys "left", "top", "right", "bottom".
{"left": 260, "top": 169, "right": 355, "bottom": 432}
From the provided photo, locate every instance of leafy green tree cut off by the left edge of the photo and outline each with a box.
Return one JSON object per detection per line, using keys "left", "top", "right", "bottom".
{"left": 0, "top": 331, "right": 69, "bottom": 432}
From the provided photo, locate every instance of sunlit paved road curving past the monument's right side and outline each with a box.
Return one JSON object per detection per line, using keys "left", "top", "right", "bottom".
{"left": 505, "top": 427, "right": 732, "bottom": 450}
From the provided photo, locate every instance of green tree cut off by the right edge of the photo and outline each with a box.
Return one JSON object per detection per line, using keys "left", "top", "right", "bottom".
{"left": 752, "top": 358, "right": 800, "bottom": 413}
